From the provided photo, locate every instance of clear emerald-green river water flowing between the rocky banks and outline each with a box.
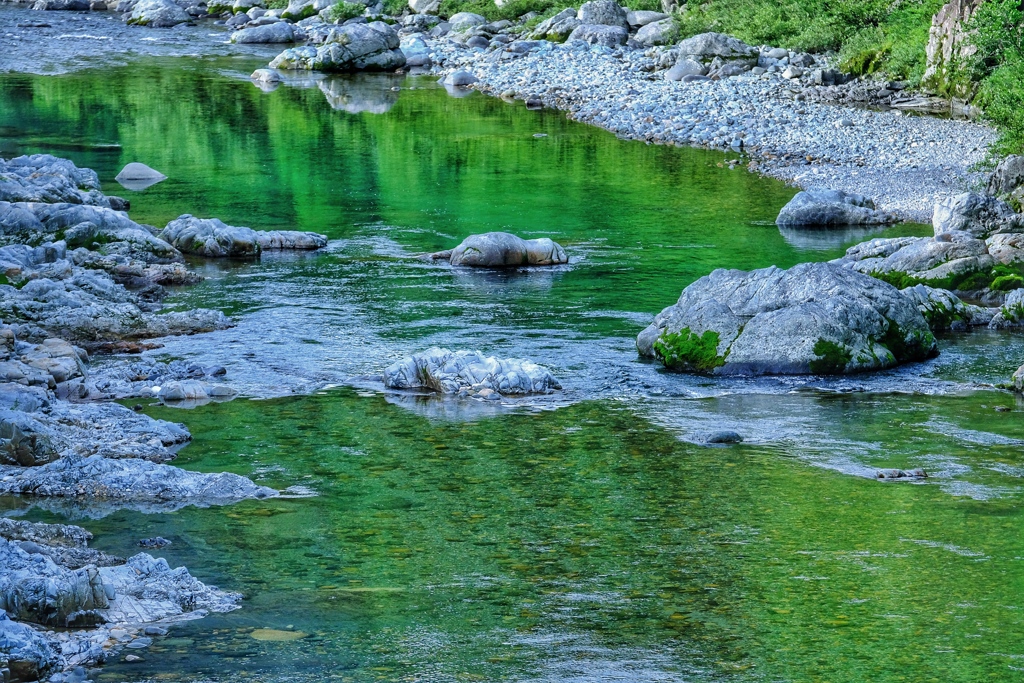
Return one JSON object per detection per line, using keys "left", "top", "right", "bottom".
{"left": 0, "top": 60, "right": 1024, "bottom": 681}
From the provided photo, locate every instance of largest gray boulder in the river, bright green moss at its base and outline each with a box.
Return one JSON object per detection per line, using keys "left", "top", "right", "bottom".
{"left": 637, "top": 263, "right": 936, "bottom": 375}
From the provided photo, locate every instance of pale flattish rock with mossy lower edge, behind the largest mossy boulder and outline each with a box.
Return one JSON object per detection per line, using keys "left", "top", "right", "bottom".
{"left": 840, "top": 232, "right": 995, "bottom": 290}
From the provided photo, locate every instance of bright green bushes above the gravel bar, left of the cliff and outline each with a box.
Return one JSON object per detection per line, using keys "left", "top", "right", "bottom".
{"left": 679, "top": 0, "right": 942, "bottom": 81}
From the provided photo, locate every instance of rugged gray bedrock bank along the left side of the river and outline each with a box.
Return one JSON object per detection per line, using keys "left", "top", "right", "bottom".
{"left": 0, "top": 155, "right": 335, "bottom": 681}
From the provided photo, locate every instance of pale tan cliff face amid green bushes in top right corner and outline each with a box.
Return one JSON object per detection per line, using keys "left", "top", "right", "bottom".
{"left": 924, "top": 0, "right": 984, "bottom": 99}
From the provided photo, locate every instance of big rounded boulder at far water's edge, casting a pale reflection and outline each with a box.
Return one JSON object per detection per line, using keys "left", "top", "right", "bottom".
{"left": 270, "top": 22, "right": 406, "bottom": 72}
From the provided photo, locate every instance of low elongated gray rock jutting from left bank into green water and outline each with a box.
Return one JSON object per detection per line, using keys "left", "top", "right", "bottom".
{"left": 160, "top": 214, "right": 327, "bottom": 258}
